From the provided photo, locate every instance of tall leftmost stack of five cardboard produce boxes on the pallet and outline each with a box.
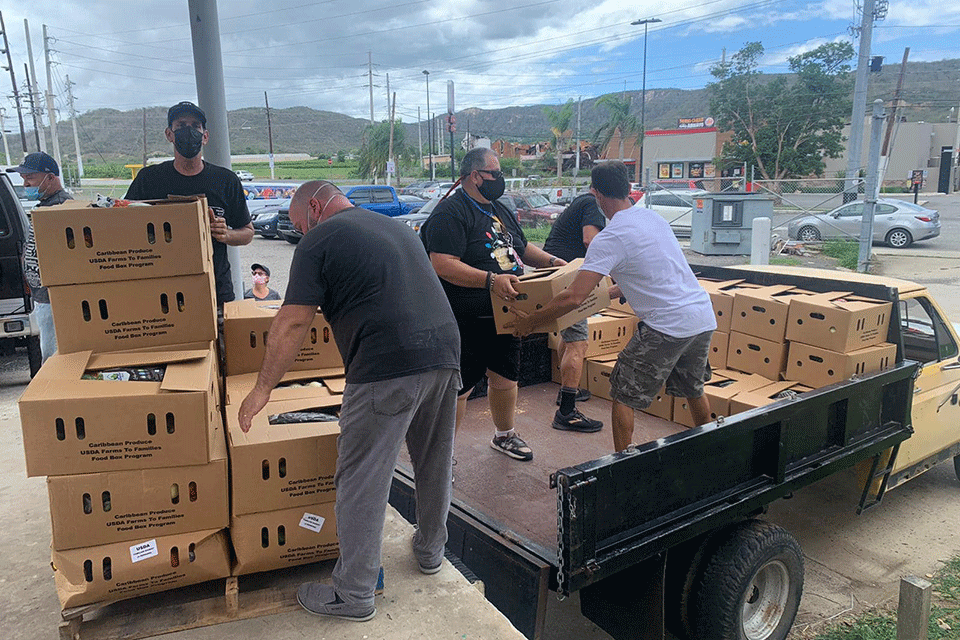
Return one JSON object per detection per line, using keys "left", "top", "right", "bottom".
{"left": 20, "top": 198, "right": 230, "bottom": 607}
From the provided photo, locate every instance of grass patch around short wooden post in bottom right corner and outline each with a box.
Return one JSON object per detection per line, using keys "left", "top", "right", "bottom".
{"left": 813, "top": 555, "right": 960, "bottom": 640}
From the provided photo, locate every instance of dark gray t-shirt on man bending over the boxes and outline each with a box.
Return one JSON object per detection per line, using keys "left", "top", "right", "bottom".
{"left": 283, "top": 208, "right": 460, "bottom": 384}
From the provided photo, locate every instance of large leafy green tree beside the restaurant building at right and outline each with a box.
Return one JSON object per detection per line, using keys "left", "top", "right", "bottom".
{"left": 707, "top": 42, "right": 854, "bottom": 180}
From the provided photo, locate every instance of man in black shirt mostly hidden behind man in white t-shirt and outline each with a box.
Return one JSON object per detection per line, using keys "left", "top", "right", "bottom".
{"left": 543, "top": 193, "right": 606, "bottom": 433}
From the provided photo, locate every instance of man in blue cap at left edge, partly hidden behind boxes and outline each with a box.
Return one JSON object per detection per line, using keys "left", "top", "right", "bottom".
{"left": 7, "top": 151, "right": 73, "bottom": 362}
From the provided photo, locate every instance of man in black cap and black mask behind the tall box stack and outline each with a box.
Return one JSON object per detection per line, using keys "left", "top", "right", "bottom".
{"left": 126, "top": 102, "right": 253, "bottom": 305}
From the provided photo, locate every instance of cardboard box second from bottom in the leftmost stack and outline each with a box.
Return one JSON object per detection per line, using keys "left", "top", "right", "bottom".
{"left": 47, "top": 429, "right": 230, "bottom": 551}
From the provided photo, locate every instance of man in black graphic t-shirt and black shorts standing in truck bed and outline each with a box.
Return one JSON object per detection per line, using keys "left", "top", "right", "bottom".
{"left": 420, "top": 148, "right": 566, "bottom": 460}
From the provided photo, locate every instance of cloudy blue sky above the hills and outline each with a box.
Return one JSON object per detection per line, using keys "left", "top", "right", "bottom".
{"left": 0, "top": 0, "right": 960, "bottom": 130}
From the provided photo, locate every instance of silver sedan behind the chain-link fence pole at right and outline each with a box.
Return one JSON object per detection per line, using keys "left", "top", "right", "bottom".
{"left": 787, "top": 198, "right": 940, "bottom": 249}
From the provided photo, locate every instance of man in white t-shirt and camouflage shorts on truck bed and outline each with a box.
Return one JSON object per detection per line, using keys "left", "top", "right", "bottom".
{"left": 506, "top": 162, "right": 717, "bottom": 451}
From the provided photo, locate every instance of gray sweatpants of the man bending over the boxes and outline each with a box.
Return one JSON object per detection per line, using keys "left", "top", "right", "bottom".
{"left": 333, "top": 369, "right": 460, "bottom": 605}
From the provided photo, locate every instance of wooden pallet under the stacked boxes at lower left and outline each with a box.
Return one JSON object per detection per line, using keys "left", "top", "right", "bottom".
{"left": 59, "top": 560, "right": 334, "bottom": 640}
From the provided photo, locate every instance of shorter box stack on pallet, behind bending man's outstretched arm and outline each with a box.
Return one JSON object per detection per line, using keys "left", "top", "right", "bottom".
{"left": 224, "top": 300, "right": 345, "bottom": 575}
